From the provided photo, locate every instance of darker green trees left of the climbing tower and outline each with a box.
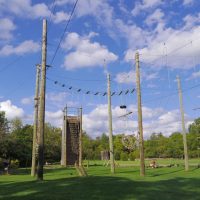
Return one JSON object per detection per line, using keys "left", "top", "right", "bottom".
{"left": 0, "top": 112, "right": 61, "bottom": 167}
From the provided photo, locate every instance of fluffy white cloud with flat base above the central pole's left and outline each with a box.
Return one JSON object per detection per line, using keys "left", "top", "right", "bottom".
{"left": 62, "top": 32, "right": 118, "bottom": 70}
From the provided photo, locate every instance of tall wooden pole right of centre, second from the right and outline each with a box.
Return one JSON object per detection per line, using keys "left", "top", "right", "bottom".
{"left": 135, "top": 52, "right": 145, "bottom": 176}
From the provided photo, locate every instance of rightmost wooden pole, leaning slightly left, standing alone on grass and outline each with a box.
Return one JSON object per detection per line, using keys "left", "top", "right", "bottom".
{"left": 176, "top": 76, "right": 189, "bottom": 171}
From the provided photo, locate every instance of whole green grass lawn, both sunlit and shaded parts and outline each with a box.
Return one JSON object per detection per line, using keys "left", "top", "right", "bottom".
{"left": 0, "top": 162, "right": 200, "bottom": 200}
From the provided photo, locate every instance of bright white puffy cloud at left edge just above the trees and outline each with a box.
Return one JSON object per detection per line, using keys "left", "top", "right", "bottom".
{"left": 0, "top": 100, "right": 24, "bottom": 120}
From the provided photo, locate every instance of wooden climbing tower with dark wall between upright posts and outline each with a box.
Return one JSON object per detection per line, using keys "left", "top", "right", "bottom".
{"left": 61, "top": 107, "right": 82, "bottom": 166}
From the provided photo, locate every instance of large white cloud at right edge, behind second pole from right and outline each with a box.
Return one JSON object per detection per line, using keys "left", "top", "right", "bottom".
{"left": 125, "top": 26, "right": 200, "bottom": 69}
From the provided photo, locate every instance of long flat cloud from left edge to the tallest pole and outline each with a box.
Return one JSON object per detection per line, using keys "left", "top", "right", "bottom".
{"left": 0, "top": 40, "right": 40, "bottom": 56}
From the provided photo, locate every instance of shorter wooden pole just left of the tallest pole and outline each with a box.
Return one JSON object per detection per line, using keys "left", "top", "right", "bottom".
{"left": 31, "top": 64, "right": 41, "bottom": 176}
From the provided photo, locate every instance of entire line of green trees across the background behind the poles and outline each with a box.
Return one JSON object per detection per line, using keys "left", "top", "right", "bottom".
{"left": 0, "top": 112, "right": 200, "bottom": 167}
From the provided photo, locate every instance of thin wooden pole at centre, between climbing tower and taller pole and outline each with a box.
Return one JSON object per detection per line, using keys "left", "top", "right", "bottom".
{"left": 107, "top": 74, "right": 115, "bottom": 174}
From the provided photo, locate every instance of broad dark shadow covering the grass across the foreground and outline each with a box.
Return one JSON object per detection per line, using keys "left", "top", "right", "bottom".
{"left": 0, "top": 176, "right": 200, "bottom": 200}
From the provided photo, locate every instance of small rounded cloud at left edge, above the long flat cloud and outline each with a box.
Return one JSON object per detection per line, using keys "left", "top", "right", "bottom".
{"left": 0, "top": 18, "right": 16, "bottom": 40}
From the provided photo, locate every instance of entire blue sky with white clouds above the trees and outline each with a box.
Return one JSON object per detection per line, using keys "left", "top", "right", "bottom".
{"left": 0, "top": 0, "right": 200, "bottom": 137}
